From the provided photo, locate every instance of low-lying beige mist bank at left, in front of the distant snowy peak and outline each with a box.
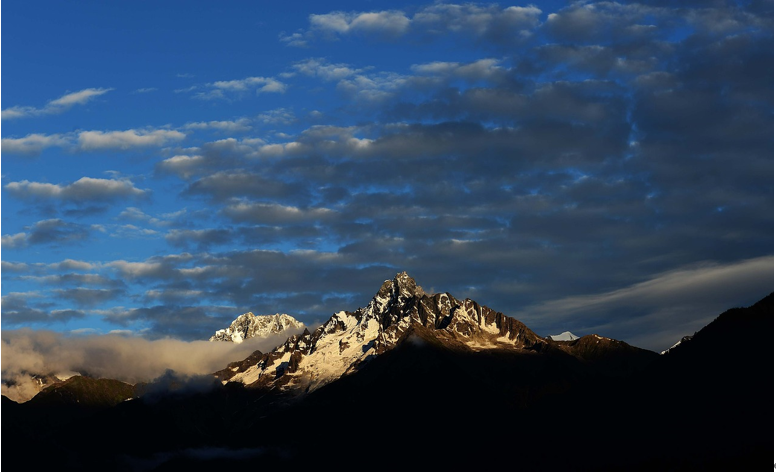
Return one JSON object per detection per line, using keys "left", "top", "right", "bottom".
{"left": 0, "top": 329, "right": 299, "bottom": 402}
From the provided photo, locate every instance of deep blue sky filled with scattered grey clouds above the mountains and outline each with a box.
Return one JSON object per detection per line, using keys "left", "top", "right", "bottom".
{"left": 0, "top": 0, "right": 774, "bottom": 350}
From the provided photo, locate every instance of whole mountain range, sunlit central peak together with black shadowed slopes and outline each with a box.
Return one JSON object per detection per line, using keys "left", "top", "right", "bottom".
{"left": 2, "top": 280, "right": 774, "bottom": 471}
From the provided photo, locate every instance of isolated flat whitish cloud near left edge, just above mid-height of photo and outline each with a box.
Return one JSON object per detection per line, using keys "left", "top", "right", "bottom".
{"left": 4, "top": 177, "right": 148, "bottom": 202}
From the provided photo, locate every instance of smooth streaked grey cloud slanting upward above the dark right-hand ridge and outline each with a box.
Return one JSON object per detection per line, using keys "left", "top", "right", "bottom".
{"left": 516, "top": 256, "right": 774, "bottom": 351}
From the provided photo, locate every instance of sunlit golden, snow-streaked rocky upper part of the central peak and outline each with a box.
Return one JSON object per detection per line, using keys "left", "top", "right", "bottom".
{"left": 216, "top": 272, "right": 656, "bottom": 394}
